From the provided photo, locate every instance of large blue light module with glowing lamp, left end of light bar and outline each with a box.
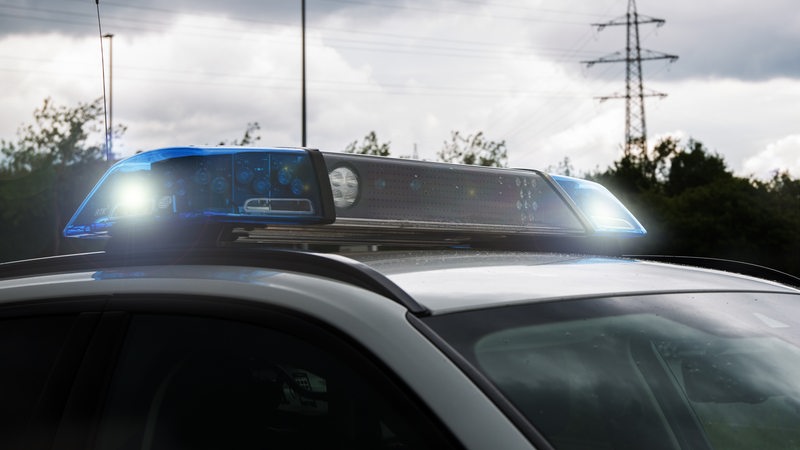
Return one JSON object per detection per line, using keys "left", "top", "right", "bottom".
{"left": 64, "top": 147, "right": 334, "bottom": 238}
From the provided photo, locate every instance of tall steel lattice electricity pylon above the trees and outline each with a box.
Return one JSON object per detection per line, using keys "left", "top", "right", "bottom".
{"left": 582, "top": 0, "right": 678, "bottom": 155}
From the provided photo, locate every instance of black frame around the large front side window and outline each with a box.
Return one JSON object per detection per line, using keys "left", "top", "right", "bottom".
{"left": 64, "top": 293, "right": 463, "bottom": 449}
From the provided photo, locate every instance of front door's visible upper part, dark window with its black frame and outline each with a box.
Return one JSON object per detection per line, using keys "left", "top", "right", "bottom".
{"left": 50, "top": 295, "right": 460, "bottom": 450}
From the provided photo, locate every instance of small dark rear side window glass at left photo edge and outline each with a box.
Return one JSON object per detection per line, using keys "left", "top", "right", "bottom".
{"left": 0, "top": 316, "right": 75, "bottom": 448}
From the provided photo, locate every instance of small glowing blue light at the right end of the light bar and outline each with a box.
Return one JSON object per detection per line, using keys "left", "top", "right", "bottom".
{"left": 551, "top": 175, "right": 647, "bottom": 237}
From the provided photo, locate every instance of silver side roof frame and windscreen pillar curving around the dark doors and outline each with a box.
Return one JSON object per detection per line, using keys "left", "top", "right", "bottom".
{"left": 0, "top": 266, "right": 532, "bottom": 449}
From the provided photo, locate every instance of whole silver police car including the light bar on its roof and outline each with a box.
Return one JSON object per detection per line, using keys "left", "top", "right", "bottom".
{"left": 0, "top": 147, "right": 800, "bottom": 450}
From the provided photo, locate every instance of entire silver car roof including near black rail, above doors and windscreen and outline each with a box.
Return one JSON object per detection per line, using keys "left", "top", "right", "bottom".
{"left": 1, "top": 248, "right": 800, "bottom": 315}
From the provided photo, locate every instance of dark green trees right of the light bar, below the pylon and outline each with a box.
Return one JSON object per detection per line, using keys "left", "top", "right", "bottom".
{"left": 592, "top": 139, "right": 800, "bottom": 275}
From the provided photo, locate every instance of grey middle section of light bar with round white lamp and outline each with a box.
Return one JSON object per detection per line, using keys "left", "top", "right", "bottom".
{"left": 323, "top": 152, "right": 587, "bottom": 235}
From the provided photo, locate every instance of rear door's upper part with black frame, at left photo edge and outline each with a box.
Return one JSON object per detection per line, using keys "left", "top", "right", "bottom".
{"left": 0, "top": 298, "right": 105, "bottom": 449}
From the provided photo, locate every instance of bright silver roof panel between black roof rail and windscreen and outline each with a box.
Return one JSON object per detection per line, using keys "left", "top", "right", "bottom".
{"left": 346, "top": 250, "right": 800, "bottom": 314}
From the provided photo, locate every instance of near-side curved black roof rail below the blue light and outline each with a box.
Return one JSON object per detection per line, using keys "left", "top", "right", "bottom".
{"left": 0, "top": 247, "right": 430, "bottom": 316}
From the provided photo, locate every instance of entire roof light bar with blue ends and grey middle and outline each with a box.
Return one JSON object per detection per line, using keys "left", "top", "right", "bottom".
{"left": 64, "top": 147, "right": 646, "bottom": 241}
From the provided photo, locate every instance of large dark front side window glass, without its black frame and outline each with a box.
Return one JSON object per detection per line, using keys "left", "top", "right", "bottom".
{"left": 97, "top": 315, "right": 456, "bottom": 450}
